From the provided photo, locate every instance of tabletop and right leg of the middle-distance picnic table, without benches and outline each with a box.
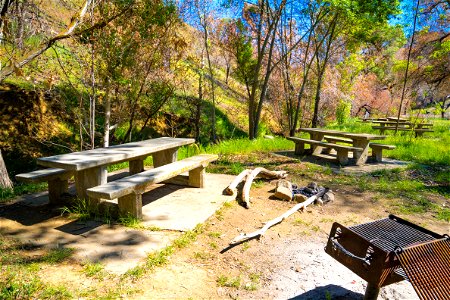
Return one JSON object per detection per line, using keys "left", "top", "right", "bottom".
{"left": 299, "top": 128, "right": 386, "bottom": 165}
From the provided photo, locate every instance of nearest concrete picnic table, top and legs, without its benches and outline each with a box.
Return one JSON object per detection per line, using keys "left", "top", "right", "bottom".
{"left": 37, "top": 137, "right": 195, "bottom": 198}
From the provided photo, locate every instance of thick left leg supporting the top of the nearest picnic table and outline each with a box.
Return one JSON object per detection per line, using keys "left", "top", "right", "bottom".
{"left": 75, "top": 166, "right": 108, "bottom": 199}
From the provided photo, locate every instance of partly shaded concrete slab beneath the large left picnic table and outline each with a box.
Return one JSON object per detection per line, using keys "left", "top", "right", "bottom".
{"left": 0, "top": 172, "right": 233, "bottom": 273}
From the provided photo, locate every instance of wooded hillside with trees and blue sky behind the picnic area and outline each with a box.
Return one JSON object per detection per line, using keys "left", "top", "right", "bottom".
{"left": 0, "top": 0, "right": 450, "bottom": 186}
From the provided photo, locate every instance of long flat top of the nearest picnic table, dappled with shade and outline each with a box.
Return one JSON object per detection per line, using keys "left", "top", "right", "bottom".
{"left": 37, "top": 137, "right": 195, "bottom": 171}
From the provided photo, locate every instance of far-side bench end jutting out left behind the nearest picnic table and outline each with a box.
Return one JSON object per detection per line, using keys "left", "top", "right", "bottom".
{"left": 16, "top": 168, "right": 74, "bottom": 204}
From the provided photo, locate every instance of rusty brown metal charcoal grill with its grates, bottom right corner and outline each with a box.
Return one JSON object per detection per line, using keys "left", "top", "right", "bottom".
{"left": 325, "top": 215, "right": 450, "bottom": 299}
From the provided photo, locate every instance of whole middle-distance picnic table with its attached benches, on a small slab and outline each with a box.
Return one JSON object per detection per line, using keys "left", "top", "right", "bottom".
{"left": 288, "top": 128, "right": 386, "bottom": 165}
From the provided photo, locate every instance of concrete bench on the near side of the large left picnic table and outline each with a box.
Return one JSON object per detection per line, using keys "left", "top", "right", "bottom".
{"left": 86, "top": 154, "right": 217, "bottom": 219}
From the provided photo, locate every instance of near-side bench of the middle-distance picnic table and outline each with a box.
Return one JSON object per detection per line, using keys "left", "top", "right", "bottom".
{"left": 287, "top": 137, "right": 363, "bottom": 165}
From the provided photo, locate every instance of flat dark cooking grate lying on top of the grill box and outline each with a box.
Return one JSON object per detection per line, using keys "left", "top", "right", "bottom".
{"left": 349, "top": 218, "right": 435, "bottom": 252}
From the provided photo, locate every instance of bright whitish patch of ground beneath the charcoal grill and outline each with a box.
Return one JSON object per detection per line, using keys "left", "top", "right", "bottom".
{"left": 267, "top": 240, "right": 419, "bottom": 299}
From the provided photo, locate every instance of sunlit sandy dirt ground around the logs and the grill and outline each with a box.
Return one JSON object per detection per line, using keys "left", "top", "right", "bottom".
{"left": 0, "top": 154, "right": 450, "bottom": 299}
